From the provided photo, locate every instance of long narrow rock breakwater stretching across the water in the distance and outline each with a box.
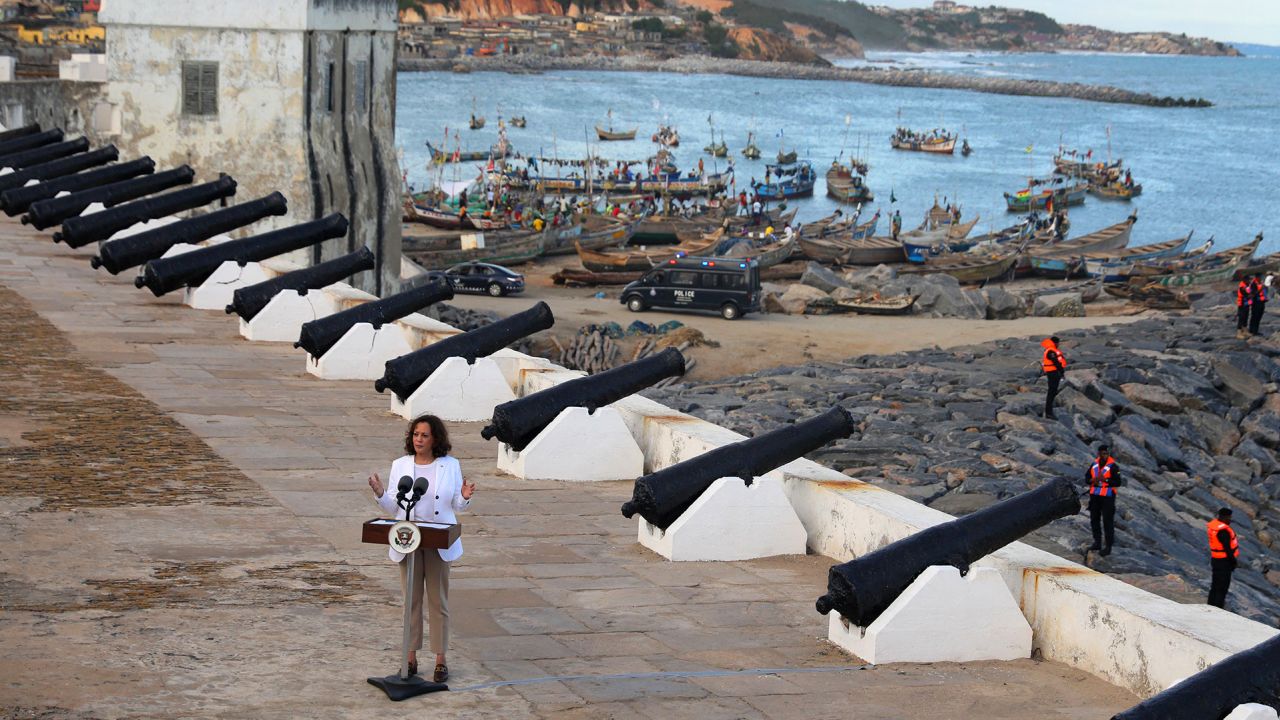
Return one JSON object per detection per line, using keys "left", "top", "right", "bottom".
{"left": 399, "top": 55, "right": 1212, "bottom": 108}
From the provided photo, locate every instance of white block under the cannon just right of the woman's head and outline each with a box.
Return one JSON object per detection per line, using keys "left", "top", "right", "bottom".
{"left": 490, "top": 406, "right": 644, "bottom": 482}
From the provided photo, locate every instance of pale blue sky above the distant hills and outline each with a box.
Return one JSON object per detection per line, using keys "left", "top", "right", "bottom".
{"left": 864, "top": 0, "right": 1280, "bottom": 45}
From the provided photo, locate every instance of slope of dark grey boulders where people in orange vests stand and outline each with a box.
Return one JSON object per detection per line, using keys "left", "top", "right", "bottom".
{"left": 644, "top": 306, "right": 1280, "bottom": 625}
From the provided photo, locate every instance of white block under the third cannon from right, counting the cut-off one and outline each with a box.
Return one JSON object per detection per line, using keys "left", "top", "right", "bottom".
{"left": 639, "top": 473, "right": 808, "bottom": 561}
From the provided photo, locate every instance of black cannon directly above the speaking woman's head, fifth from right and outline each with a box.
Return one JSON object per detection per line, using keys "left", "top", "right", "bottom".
{"left": 374, "top": 302, "right": 556, "bottom": 400}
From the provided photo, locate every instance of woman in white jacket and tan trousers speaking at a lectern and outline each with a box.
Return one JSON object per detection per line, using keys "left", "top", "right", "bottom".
{"left": 369, "top": 415, "right": 476, "bottom": 683}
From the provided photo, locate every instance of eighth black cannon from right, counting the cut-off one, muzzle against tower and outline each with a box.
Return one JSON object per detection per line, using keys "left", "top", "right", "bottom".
{"left": 136, "top": 213, "right": 347, "bottom": 297}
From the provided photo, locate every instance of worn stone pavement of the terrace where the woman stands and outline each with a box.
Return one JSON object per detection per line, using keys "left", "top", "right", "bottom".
{"left": 0, "top": 215, "right": 1135, "bottom": 719}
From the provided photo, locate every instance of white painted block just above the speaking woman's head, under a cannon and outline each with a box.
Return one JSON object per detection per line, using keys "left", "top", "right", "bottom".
{"left": 392, "top": 357, "right": 514, "bottom": 422}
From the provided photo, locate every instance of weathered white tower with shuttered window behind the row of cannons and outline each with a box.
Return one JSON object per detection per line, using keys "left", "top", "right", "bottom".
{"left": 100, "top": 0, "right": 401, "bottom": 295}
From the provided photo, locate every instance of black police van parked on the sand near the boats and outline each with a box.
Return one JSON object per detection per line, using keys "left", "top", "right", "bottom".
{"left": 620, "top": 258, "right": 760, "bottom": 320}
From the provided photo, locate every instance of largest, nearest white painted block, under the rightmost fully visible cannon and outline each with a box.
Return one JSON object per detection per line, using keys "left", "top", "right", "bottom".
{"left": 827, "top": 565, "right": 1032, "bottom": 665}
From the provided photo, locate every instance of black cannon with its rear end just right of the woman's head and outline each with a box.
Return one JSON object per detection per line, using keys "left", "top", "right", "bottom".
{"left": 480, "top": 347, "right": 685, "bottom": 451}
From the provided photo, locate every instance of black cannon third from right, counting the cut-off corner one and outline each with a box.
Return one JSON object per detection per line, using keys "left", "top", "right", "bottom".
{"left": 622, "top": 407, "right": 854, "bottom": 530}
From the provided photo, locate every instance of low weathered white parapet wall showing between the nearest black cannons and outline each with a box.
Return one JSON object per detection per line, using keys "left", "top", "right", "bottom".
{"left": 506, "top": 369, "right": 1280, "bottom": 697}
